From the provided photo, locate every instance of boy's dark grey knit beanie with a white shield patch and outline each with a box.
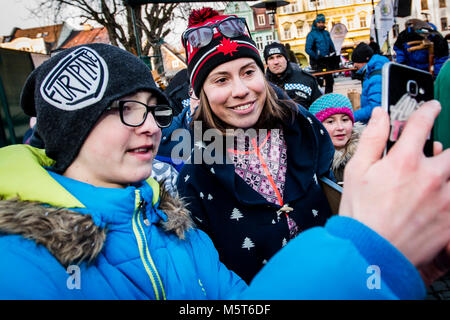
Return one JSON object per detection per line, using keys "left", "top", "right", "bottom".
{"left": 20, "top": 43, "right": 169, "bottom": 173}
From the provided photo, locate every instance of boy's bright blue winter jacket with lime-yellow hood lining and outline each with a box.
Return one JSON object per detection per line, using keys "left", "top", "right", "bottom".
{"left": 0, "top": 145, "right": 425, "bottom": 299}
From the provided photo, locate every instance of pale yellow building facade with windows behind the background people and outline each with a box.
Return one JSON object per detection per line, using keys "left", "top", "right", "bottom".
{"left": 277, "top": 0, "right": 450, "bottom": 66}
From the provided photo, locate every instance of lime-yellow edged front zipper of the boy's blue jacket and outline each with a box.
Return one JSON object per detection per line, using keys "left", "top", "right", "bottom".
{"left": 132, "top": 190, "right": 166, "bottom": 300}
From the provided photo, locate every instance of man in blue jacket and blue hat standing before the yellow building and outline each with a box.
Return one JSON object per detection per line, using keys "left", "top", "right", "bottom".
{"left": 305, "top": 13, "right": 336, "bottom": 93}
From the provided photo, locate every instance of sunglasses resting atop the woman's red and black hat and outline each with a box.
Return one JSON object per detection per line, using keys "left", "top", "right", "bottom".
{"left": 181, "top": 17, "right": 251, "bottom": 48}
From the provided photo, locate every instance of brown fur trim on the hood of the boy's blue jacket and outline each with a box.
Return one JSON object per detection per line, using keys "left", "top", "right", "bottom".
{"left": 0, "top": 183, "right": 193, "bottom": 266}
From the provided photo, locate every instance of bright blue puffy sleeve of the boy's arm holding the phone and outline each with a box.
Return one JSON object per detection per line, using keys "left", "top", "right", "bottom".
{"left": 240, "top": 217, "right": 426, "bottom": 299}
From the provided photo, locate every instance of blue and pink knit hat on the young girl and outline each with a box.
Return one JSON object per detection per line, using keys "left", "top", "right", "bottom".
{"left": 309, "top": 93, "right": 355, "bottom": 123}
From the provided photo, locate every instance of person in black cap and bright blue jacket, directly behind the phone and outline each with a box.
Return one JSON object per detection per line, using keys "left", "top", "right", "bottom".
{"left": 351, "top": 42, "right": 389, "bottom": 124}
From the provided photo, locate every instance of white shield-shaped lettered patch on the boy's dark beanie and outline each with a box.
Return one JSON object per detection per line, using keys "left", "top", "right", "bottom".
{"left": 40, "top": 47, "right": 109, "bottom": 111}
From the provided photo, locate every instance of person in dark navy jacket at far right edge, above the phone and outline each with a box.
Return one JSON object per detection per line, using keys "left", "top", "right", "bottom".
{"left": 394, "top": 19, "right": 448, "bottom": 78}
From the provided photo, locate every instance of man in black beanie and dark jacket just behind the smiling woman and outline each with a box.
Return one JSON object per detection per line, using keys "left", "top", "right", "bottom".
{"left": 264, "top": 42, "right": 322, "bottom": 109}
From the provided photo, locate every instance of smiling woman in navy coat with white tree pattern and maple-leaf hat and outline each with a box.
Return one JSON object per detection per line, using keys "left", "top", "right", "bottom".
{"left": 178, "top": 9, "right": 333, "bottom": 282}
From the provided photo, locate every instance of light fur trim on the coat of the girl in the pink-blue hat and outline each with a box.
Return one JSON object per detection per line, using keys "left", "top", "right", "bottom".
{"left": 331, "top": 122, "right": 366, "bottom": 182}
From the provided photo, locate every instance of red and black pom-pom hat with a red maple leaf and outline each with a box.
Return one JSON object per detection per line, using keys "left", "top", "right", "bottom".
{"left": 183, "top": 8, "right": 264, "bottom": 97}
